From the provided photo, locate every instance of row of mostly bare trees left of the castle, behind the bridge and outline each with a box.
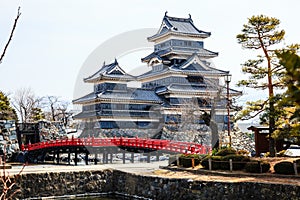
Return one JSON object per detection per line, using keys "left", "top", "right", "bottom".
{"left": 0, "top": 88, "right": 73, "bottom": 125}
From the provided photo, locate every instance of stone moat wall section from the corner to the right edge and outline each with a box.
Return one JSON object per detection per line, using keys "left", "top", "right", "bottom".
{"left": 114, "top": 171, "right": 300, "bottom": 200}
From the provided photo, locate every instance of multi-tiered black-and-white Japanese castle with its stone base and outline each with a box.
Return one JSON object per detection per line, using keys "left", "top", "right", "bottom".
{"left": 73, "top": 13, "right": 241, "bottom": 147}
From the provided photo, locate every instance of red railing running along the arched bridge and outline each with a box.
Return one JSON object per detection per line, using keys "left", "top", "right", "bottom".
{"left": 21, "top": 137, "right": 211, "bottom": 154}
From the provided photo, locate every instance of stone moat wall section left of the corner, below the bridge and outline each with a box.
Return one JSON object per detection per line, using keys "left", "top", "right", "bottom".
{"left": 13, "top": 170, "right": 113, "bottom": 199}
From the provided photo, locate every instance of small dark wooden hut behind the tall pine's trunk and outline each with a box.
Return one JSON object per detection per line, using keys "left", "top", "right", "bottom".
{"left": 247, "top": 126, "right": 283, "bottom": 156}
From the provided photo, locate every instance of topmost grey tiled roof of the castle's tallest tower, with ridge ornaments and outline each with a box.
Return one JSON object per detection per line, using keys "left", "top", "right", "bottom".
{"left": 148, "top": 12, "right": 211, "bottom": 42}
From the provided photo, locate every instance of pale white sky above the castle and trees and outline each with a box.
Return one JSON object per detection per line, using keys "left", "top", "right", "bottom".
{"left": 0, "top": 0, "right": 300, "bottom": 108}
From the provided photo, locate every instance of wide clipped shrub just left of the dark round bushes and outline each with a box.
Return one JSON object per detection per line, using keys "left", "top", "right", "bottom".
{"left": 220, "top": 154, "right": 250, "bottom": 170}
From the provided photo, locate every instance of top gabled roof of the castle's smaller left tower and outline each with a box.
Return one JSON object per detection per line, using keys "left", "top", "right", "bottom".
{"left": 84, "top": 59, "right": 135, "bottom": 82}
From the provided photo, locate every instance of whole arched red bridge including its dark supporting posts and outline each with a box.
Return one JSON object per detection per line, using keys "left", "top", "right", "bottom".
{"left": 21, "top": 137, "right": 211, "bottom": 165}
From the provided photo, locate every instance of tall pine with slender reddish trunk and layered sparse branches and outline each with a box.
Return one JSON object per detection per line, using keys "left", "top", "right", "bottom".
{"left": 237, "top": 15, "right": 285, "bottom": 156}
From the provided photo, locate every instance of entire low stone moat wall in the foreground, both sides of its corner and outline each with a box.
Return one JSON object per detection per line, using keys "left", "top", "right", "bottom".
{"left": 5, "top": 170, "right": 300, "bottom": 200}
